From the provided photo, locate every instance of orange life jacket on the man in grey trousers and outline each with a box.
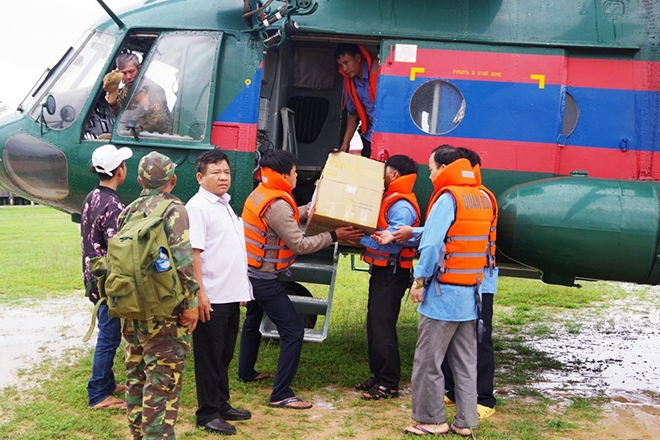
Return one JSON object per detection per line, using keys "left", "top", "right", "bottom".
{"left": 427, "top": 159, "right": 497, "bottom": 286}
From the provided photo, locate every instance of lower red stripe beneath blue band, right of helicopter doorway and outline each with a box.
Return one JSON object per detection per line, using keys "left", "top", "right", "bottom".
{"left": 372, "top": 133, "right": 660, "bottom": 180}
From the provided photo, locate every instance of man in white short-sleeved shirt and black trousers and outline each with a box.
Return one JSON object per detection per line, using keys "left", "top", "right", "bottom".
{"left": 186, "top": 150, "right": 253, "bottom": 435}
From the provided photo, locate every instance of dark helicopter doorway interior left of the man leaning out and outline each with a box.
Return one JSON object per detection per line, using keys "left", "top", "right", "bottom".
{"left": 257, "top": 36, "right": 377, "bottom": 205}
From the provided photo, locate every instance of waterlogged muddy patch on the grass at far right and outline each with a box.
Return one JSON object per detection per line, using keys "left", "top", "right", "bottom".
{"left": 516, "top": 284, "right": 660, "bottom": 440}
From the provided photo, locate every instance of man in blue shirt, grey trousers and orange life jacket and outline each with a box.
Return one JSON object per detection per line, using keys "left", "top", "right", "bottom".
{"left": 406, "top": 146, "right": 495, "bottom": 436}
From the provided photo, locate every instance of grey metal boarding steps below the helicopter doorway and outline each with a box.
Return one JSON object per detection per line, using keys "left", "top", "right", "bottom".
{"left": 259, "top": 243, "right": 339, "bottom": 342}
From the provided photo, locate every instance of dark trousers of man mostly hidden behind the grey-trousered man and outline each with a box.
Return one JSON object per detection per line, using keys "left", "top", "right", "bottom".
{"left": 442, "top": 293, "right": 496, "bottom": 408}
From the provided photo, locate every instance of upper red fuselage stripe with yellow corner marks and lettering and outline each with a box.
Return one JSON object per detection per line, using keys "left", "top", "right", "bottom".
{"left": 382, "top": 49, "right": 660, "bottom": 91}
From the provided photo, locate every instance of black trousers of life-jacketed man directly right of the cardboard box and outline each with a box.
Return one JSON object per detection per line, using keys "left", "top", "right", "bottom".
{"left": 367, "top": 266, "right": 410, "bottom": 389}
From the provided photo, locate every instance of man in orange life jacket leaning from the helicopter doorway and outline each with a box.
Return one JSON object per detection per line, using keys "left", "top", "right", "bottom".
{"left": 335, "top": 44, "right": 378, "bottom": 157}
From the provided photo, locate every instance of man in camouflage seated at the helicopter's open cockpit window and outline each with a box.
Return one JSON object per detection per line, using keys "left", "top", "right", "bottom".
{"left": 103, "top": 53, "right": 172, "bottom": 133}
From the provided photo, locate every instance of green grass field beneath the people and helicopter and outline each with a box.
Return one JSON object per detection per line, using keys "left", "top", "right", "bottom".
{"left": 0, "top": 207, "right": 621, "bottom": 440}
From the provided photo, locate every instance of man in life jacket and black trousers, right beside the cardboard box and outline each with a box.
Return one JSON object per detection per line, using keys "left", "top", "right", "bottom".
{"left": 355, "top": 155, "right": 421, "bottom": 400}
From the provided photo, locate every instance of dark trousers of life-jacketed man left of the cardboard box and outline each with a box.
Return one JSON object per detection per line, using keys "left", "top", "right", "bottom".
{"left": 238, "top": 278, "right": 305, "bottom": 402}
